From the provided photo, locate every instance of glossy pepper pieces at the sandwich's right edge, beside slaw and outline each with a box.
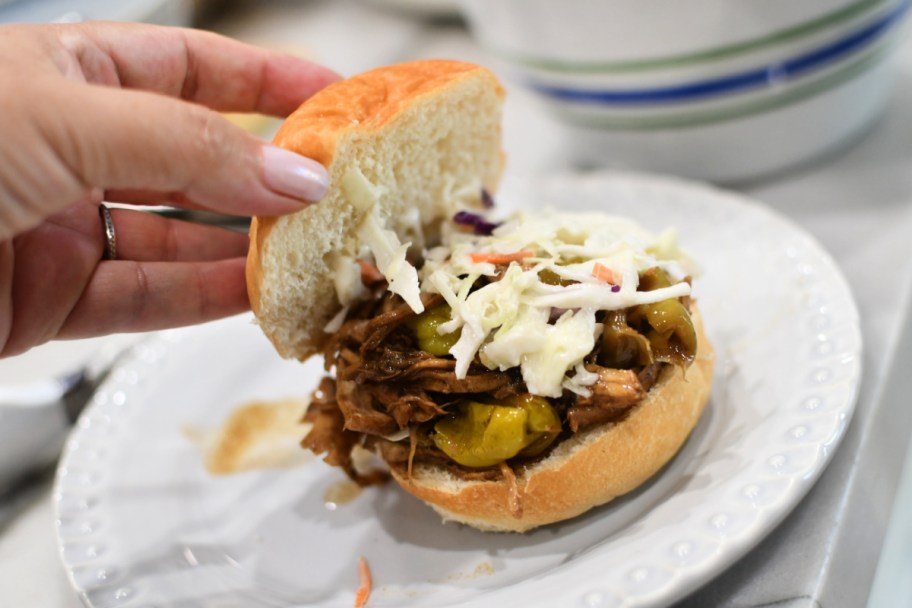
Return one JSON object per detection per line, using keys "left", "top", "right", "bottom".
{"left": 627, "top": 268, "right": 697, "bottom": 367}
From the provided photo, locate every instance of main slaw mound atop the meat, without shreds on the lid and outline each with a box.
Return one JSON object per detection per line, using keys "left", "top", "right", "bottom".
{"left": 420, "top": 212, "right": 690, "bottom": 397}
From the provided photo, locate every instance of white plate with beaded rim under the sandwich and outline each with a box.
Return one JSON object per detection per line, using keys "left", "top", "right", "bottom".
{"left": 57, "top": 175, "right": 861, "bottom": 608}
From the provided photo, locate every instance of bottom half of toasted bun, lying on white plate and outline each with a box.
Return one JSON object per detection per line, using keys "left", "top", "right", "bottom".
{"left": 392, "top": 309, "right": 715, "bottom": 532}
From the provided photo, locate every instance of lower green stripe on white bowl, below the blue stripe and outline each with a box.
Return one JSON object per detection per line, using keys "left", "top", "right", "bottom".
{"left": 558, "top": 43, "right": 894, "bottom": 131}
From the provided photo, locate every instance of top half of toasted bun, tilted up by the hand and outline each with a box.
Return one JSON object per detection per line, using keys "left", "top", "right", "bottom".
{"left": 247, "top": 61, "right": 503, "bottom": 359}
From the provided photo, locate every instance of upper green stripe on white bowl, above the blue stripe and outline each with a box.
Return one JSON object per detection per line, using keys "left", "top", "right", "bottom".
{"left": 494, "top": 0, "right": 889, "bottom": 74}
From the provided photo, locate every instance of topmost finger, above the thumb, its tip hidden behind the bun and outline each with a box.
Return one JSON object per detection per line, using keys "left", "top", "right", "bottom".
{"left": 59, "top": 22, "right": 339, "bottom": 116}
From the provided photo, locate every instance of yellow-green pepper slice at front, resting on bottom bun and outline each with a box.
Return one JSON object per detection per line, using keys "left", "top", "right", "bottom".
{"left": 431, "top": 395, "right": 561, "bottom": 468}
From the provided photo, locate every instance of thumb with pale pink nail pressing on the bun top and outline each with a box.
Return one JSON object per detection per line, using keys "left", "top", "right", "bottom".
{"left": 31, "top": 77, "right": 329, "bottom": 215}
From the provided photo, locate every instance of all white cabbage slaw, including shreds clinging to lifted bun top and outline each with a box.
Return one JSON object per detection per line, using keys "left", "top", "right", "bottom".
{"left": 327, "top": 179, "right": 693, "bottom": 397}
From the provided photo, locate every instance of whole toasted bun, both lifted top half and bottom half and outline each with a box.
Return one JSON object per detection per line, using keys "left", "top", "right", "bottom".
{"left": 247, "top": 61, "right": 713, "bottom": 531}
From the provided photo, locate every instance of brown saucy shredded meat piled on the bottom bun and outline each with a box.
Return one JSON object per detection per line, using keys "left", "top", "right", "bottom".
{"left": 302, "top": 288, "right": 666, "bottom": 484}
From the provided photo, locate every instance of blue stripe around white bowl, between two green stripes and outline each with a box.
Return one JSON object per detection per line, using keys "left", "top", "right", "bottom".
{"left": 529, "top": 0, "right": 912, "bottom": 105}
